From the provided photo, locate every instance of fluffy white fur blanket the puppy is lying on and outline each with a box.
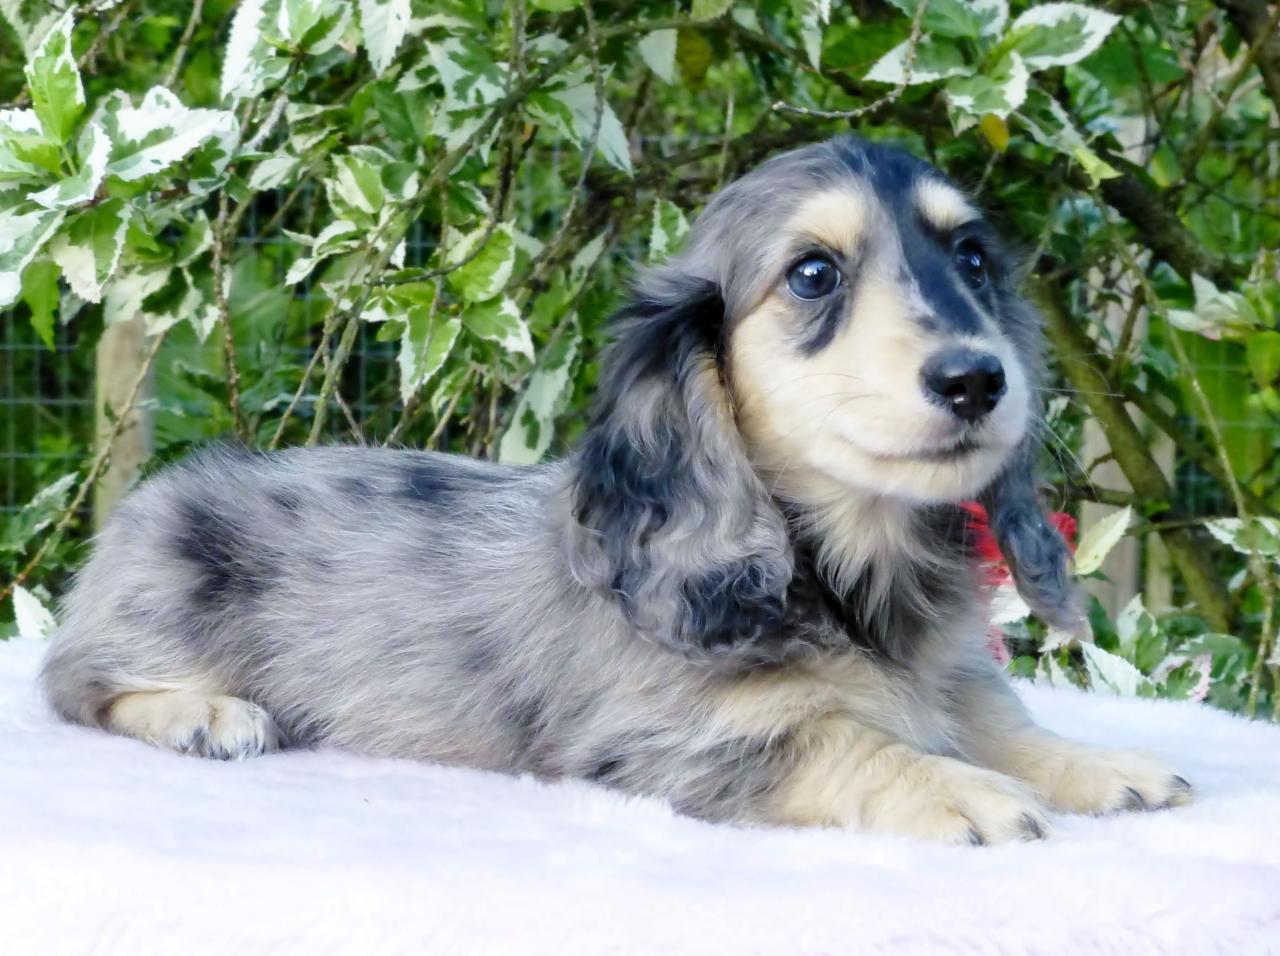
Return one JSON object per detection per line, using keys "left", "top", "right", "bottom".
{"left": 0, "top": 641, "right": 1280, "bottom": 956}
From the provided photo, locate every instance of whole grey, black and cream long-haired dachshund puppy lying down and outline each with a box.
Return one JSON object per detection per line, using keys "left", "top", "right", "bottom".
{"left": 44, "top": 138, "right": 1190, "bottom": 843}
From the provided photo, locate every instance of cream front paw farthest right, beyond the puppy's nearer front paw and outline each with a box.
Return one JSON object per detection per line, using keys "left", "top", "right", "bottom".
{"left": 1028, "top": 745, "right": 1192, "bottom": 814}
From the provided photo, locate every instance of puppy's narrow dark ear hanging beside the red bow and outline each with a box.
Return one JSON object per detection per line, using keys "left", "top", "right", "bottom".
{"left": 982, "top": 435, "right": 1089, "bottom": 635}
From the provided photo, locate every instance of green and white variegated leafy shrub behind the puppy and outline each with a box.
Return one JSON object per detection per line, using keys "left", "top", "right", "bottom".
{"left": 0, "top": 0, "right": 1280, "bottom": 713}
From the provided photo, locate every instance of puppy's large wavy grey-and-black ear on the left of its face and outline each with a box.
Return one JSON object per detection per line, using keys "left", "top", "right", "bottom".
{"left": 572, "top": 264, "right": 792, "bottom": 663}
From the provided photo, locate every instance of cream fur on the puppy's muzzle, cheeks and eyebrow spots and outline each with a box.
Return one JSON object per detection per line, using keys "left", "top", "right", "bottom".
{"left": 728, "top": 183, "right": 1030, "bottom": 500}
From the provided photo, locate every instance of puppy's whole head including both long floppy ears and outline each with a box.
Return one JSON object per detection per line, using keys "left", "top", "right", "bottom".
{"left": 575, "top": 138, "right": 1076, "bottom": 665}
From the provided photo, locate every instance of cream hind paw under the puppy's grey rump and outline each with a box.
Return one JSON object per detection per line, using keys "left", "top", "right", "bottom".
{"left": 108, "top": 691, "right": 279, "bottom": 760}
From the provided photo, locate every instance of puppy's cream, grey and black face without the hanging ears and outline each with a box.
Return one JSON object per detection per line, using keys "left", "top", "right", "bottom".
{"left": 689, "top": 141, "right": 1033, "bottom": 509}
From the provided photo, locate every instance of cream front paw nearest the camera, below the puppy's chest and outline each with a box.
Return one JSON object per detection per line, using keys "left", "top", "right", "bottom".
{"left": 860, "top": 756, "right": 1048, "bottom": 846}
